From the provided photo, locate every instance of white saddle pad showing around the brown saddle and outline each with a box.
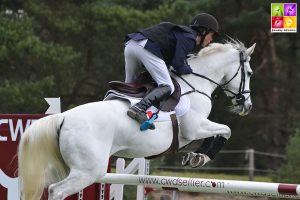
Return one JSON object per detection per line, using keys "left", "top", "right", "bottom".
{"left": 103, "top": 90, "right": 190, "bottom": 121}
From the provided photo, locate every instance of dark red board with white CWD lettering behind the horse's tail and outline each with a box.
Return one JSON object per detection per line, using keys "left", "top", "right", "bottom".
{"left": 0, "top": 114, "right": 46, "bottom": 200}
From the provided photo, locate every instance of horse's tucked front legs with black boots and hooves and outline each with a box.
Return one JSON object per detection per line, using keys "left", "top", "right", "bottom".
{"left": 182, "top": 118, "right": 231, "bottom": 167}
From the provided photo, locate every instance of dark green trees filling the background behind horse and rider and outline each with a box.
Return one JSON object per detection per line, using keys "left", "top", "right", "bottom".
{"left": 0, "top": 0, "right": 300, "bottom": 172}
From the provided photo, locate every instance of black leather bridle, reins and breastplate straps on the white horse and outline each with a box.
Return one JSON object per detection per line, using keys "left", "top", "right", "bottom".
{"left": 172, "top": 52, "right": 251, "bottom": 105}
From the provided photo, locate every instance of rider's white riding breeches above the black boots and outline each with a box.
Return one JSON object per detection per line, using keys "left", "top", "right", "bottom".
{"left": 124, "top": 39, "right": 174, "bottom": 93}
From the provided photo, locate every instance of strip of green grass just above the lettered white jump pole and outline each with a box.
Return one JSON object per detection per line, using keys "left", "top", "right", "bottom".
{"left": 151, "top": 171, "right": 272, "bottom": 182}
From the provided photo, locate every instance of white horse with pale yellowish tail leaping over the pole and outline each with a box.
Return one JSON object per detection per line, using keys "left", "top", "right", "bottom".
{"left": 18, "top": 41, "right": 255, "bottom": 200}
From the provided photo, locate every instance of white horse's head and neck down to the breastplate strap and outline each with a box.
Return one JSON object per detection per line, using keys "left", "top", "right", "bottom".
{"left": 186, "top": 38, "right": 255, "bottom": 116}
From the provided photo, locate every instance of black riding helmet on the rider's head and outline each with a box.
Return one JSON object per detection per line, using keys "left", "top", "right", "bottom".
{"left": 190, "top": 13, "right": 219, "bottom": 34}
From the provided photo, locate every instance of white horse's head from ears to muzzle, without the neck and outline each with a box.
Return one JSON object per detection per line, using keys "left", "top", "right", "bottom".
{"left": 221, "top": 41, "right": 256, "bottom": 116}
